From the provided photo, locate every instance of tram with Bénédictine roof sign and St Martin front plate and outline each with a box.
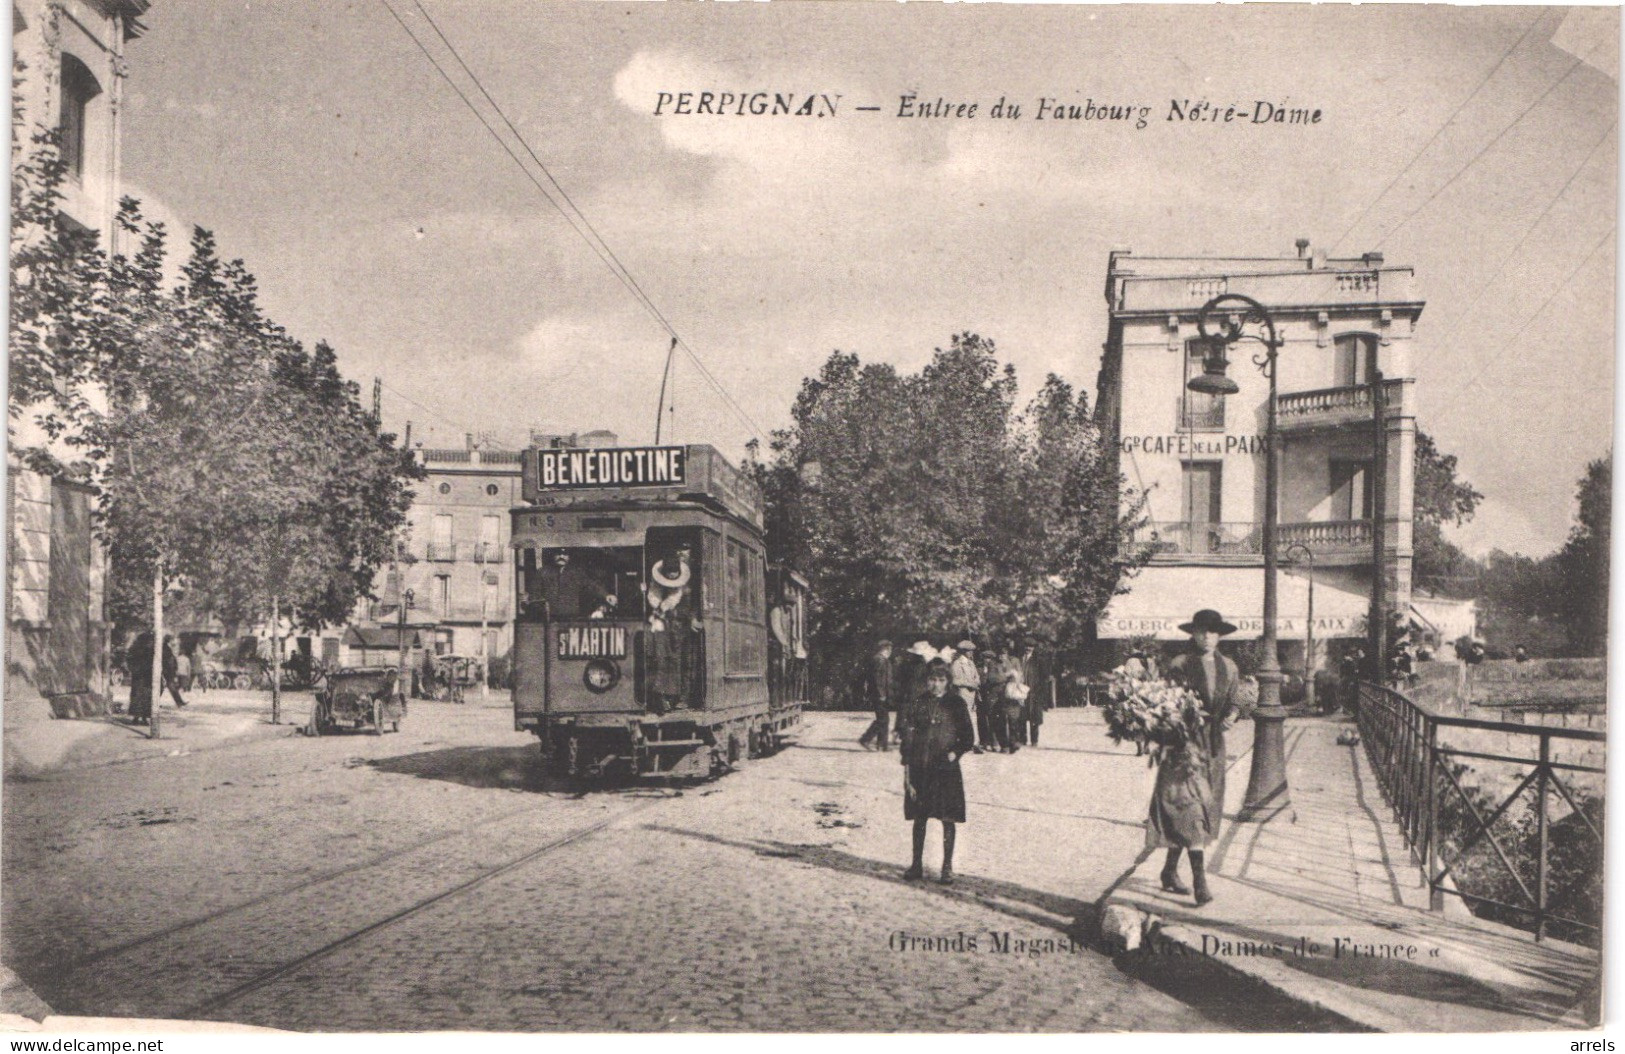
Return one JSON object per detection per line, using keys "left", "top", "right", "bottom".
{"left": 512, "top": 445, "right": 808, "bottom": 778}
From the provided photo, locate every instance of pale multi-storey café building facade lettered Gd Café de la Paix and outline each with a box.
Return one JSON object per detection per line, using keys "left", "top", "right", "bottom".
{"left": 1097, "top": 242, "right": 1424, "bottom": 669}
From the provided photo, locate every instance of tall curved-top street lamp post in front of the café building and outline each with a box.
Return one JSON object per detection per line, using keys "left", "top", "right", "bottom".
{"left": 1186, "top": 292, "right": 1292, "bottom": 822}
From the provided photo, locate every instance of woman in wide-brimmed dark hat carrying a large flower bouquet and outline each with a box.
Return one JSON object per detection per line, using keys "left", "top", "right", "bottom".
{"left": 1147, "top": 607, "right": 1240, "bottom": 905}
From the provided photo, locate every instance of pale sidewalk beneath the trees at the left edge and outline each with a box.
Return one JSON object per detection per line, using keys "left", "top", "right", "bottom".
{"left": 3, "top": 689, "right": 312, "bottom": 780}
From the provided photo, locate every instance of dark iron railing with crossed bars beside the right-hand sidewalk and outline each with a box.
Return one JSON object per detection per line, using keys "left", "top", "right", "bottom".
{"left": 1357, "top": 684, "right": 1607, "bottom": 940}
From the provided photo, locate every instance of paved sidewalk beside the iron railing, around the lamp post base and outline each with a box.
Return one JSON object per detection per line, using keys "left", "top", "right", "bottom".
{"left": 1102, "top": 719, "right": 1599, "bottom": 1031}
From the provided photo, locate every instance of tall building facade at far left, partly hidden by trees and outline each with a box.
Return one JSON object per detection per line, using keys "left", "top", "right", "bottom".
{"left": 7, "top": 0, "right": 148, "bottom": 721}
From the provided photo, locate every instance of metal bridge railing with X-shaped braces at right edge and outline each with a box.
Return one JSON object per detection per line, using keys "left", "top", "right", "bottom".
{"left": 1357, "top": 684, "right": 1607, "bottom": 944}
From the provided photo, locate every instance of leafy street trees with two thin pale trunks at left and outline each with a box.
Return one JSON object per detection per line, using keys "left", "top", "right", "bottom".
{"left": 25, "top": 189, "right": 421, "bottom": 736}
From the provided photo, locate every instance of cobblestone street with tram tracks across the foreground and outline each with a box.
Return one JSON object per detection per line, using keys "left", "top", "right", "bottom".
{"left": 5, "top": 700, "right": 1222, "bottom": 1031}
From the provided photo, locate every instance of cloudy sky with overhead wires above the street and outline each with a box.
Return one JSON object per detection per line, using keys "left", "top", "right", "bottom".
{"left": 111, "top": 0, "right": 1619, "bottom": 555}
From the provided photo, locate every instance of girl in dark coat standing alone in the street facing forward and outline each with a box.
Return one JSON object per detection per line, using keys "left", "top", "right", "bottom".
{"left": 902, "top": 659, "right": 977, "bottom": 885}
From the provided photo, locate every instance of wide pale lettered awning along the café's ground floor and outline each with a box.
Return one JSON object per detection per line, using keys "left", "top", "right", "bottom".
{"left": 1095, "top": 567, "right": 1370, "bottom": 640}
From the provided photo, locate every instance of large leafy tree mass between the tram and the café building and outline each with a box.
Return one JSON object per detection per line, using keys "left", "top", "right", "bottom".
{"left": 751, "top": 333, "right": 1136, "bottom": 698}
